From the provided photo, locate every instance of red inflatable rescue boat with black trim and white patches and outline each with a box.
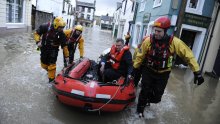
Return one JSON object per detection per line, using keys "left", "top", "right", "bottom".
{"left": 53, "top": 58, "right": 135, "bottom": 112}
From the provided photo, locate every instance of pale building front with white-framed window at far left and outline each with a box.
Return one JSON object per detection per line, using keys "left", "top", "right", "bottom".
{"left": 0, "top": 0, "right": 32, "bottom": 36}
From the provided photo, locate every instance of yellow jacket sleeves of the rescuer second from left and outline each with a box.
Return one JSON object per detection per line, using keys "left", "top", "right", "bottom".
{"left": 64, "top": 29, "right": 84, "bottom": 57}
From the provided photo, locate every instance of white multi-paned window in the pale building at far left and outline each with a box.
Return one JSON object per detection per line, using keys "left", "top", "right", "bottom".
{"left": 6, "top": 0, "right": 23, "bottom": 23}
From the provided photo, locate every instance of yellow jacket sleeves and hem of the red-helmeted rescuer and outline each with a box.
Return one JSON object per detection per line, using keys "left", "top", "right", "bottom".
{"left": 133, "top": 37, "right": 199, "bottom": 73}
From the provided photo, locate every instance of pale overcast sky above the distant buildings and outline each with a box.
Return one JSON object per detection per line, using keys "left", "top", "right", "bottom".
{"left": 76, "top": 0, "right": 122, "bottom": 16}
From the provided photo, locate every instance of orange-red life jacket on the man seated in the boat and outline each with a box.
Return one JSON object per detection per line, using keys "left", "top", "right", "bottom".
{"left": 108, "top": 45, "right": 129, "bottom": 70}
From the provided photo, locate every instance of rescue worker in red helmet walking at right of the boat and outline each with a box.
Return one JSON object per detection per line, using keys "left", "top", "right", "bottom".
{"left": 133, "top": 16, "right": 204, "bottom": 117}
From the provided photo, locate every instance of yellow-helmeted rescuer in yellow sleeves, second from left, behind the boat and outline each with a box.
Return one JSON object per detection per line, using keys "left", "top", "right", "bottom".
{"left": 64, "top": 25, "right": 84, "bottom": 67}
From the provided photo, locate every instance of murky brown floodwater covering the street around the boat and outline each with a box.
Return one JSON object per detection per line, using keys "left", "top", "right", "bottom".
{"left": 0, "top": 27, "right": 220, "bottom": 124}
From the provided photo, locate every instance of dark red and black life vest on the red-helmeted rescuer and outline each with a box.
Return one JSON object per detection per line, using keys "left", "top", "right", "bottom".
{"left": 146, "top": 35, "right": 173, "bottom": 71}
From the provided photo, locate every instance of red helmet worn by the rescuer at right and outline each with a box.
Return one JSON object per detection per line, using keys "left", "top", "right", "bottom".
{"left": 154, "top": 16, "right": 170, "bottom": 29}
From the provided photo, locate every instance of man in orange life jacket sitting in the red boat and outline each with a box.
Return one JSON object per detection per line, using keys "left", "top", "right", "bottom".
{"left": 98, "top": 38, "right": 133, "bottom": 82}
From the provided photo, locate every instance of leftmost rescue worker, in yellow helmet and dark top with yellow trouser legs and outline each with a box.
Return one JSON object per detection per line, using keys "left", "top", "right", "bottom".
{"left": 34, "top": 17, "right": 69, "bottom": 82}
